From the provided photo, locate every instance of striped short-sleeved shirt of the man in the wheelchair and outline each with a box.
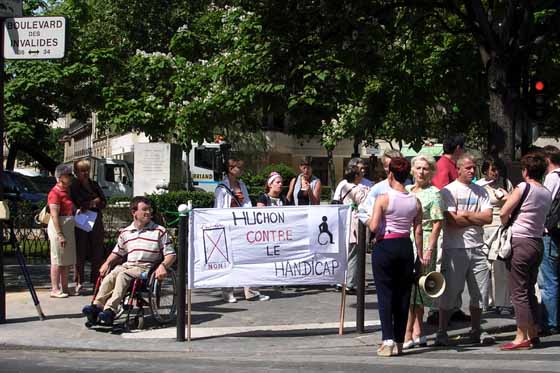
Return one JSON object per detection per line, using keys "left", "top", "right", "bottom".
{"left": 113, "top": 221, "right": 175, "bottom": 265}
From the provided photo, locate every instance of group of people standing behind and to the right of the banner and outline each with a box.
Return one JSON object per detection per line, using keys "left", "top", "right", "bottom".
{"left": 215, "top": 135, "right": 560, "bottom": 356}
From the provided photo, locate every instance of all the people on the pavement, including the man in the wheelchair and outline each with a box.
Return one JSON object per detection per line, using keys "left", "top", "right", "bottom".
{"left": 44, "top": 136, "right": 560, "bottom": 356}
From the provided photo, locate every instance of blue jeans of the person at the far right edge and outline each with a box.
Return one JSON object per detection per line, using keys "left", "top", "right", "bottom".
{"left": 537, "top": 236, "right": 560, "bottom": 330}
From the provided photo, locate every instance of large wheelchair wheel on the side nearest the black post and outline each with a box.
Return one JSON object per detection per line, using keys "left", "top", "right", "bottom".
{"left": 148, "top": 269, "right": 177, "bottom": 324}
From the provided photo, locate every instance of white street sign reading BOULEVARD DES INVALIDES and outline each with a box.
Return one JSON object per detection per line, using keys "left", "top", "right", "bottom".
{"left": 4, "top": 17, "right": 66, "bottom": 60}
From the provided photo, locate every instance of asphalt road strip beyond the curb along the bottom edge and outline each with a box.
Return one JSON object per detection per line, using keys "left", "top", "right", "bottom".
{"left": 0, "top": 349, "right": 560, "bottom": 373}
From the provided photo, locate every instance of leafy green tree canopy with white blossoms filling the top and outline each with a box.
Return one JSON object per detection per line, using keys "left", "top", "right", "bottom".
{"left": 5, "top": 0, "right": 560, "bottom": 166}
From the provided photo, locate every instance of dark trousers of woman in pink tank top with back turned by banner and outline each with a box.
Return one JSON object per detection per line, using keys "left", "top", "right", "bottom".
{"left": 371, "top": 238, "right": 414, "bottom": 343}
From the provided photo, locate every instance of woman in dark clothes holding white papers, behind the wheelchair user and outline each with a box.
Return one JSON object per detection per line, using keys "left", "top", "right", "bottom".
{"left": 70, "top": 159, "right": 107, "bottom": 294}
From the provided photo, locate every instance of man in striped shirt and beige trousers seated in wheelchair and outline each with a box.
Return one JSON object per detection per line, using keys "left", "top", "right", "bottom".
{"left": 82, "top": 197, "right": 176, "bottom": 325}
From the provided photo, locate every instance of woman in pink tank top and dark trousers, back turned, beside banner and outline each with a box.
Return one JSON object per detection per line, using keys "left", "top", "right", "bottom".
{"left": 369, "top": 158, "right": 422, "bottom": 356}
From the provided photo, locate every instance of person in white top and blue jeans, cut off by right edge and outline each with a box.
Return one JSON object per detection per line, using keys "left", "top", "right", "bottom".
{"left": 537, "top": 145, "right": 560, "bottom": 334}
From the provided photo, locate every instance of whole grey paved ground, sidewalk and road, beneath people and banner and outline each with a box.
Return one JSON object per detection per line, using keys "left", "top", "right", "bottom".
{"left": 0, "top": 258, "right": 560, "bottom": 372}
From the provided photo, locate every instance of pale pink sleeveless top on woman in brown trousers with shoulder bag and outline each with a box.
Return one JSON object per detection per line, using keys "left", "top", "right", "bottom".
{"left": 511, "top": 182, "right": 552, "bottom": 238}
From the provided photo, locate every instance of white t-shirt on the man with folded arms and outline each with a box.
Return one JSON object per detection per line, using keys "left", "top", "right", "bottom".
{"left": 441, "top": 180, "right": 492, "bottom": 248}
